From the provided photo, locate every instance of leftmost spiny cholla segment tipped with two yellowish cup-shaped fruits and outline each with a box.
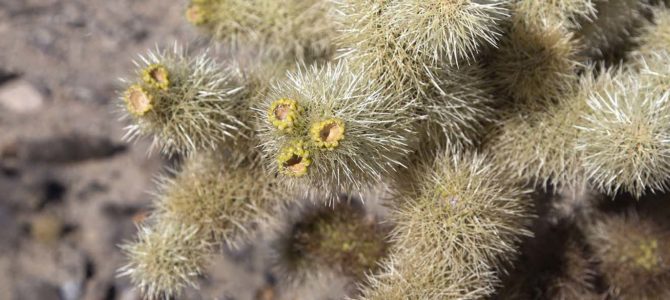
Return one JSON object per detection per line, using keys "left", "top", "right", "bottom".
{"left": 122, "top": 45, "right": 251, "bottom": 154}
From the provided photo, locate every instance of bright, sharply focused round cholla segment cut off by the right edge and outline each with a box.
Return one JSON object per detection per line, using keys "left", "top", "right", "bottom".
{"left": 577, "top": 70, "right": 670, "bottom": 197}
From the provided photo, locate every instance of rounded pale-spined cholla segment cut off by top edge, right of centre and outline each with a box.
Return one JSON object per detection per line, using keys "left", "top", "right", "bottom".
{"left": 384, "top": 0, "right": 511, "bottom": 66}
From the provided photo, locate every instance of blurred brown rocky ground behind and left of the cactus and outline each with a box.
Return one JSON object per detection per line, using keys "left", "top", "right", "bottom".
{"left": 0, "top": 0, "right": 296, "bottom": 300}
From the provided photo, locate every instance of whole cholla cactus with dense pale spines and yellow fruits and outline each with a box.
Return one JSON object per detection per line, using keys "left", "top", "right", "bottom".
{"left": 119, "top": 0, "right": 670, "bottom": 300}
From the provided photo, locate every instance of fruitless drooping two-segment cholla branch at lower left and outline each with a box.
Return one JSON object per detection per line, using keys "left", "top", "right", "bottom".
{"left": 121, "top": 155, "right": 293, "bottom": 299}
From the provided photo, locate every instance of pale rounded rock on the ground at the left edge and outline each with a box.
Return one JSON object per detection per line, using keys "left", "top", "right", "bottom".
{"left": 0, "top": 80, "right": 44, "bottom": 113}
